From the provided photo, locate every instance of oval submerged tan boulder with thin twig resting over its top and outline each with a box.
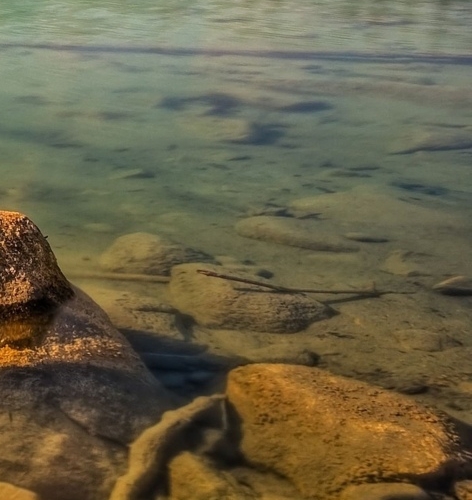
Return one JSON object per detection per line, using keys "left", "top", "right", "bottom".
{"left": 169, "top": 264, "right": 333, "bottom": 333}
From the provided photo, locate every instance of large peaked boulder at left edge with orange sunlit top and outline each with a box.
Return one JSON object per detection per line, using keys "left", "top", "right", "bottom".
{"left": 0, "top": 212, "right": 171, "bottom": 500}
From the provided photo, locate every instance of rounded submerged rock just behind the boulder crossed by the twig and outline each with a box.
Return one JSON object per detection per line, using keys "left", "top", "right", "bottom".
{"left": 100, "top": 233, "right": 213, "bottom": 275}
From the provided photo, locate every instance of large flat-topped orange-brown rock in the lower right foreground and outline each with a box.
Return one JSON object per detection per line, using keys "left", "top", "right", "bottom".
{"left": 227, "top": 364, "right": 466, "bottom": 500}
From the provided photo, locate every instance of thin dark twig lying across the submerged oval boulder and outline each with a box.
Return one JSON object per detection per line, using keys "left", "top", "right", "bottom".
{"left": 197, "top": 269, "right": 415, "bottom": 297}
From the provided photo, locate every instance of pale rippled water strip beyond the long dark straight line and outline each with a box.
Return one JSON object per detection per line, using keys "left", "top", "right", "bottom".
{"left": 0, "top": 1, "right": 472, "bottom": 52}
